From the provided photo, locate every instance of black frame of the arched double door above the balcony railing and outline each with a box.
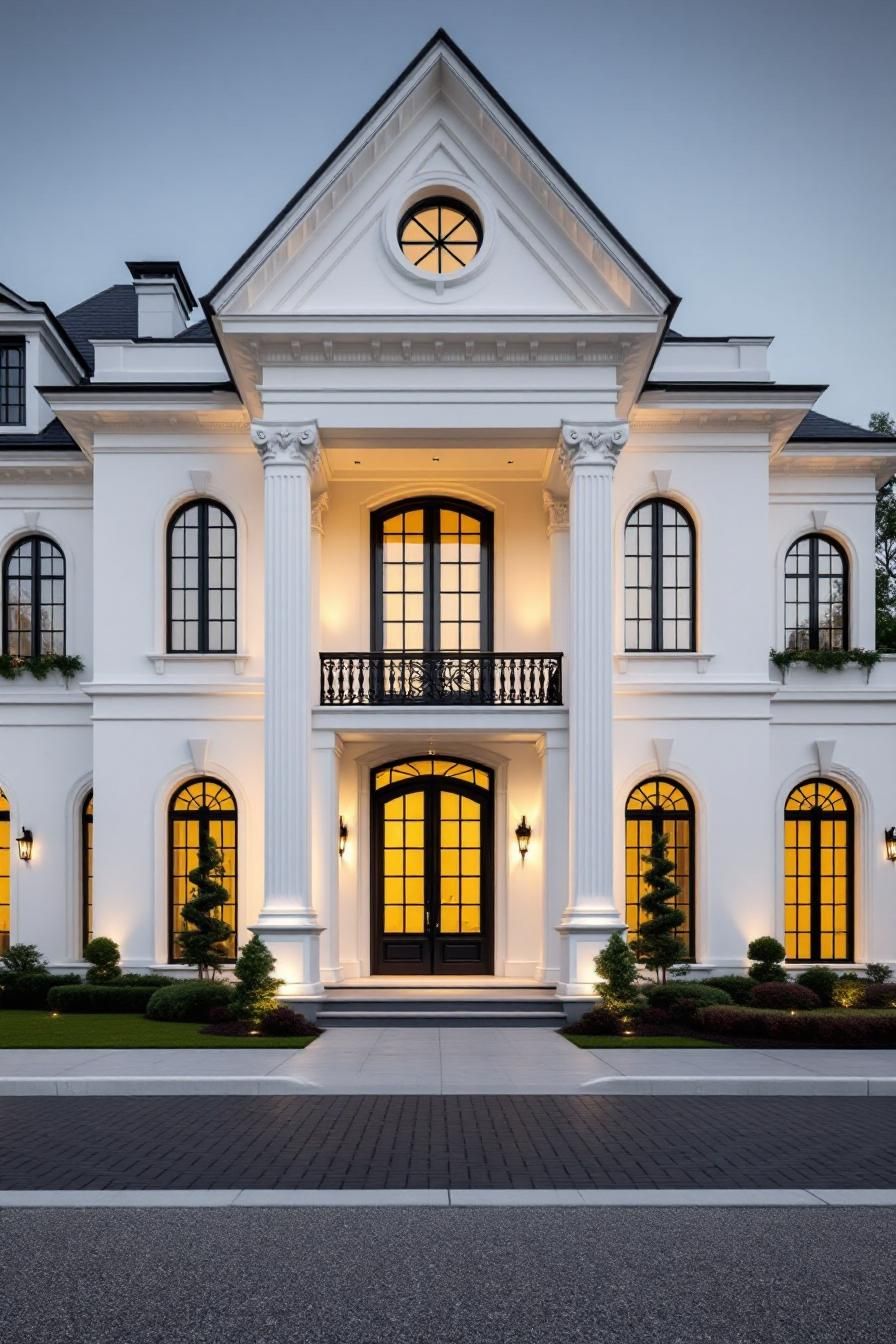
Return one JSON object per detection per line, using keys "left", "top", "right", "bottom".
{"left": 371, "top": 495, "right": 494, "bottom": 657}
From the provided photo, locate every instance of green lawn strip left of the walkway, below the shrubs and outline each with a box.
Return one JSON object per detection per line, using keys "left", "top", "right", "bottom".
{"left": 0, "top": 1008, "right": 316, "bottom": 1050}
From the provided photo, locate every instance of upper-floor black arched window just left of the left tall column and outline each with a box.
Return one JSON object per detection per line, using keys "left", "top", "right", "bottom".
{"left": 168, "top": 500, "right": 236, "bottom": 653}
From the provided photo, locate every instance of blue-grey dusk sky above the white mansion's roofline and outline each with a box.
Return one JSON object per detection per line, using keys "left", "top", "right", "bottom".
{"left": 0, "top": 0, "right": 896, "bottom": 423}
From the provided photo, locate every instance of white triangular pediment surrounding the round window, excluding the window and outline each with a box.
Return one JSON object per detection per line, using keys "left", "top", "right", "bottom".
{"left": 206, "top": 34, "right": 673, "bottom": 321}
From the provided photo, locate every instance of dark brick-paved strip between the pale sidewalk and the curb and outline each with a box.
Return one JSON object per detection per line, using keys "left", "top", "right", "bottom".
{"left": 0, "top": 1097, "right": 896, "bottom": 1191}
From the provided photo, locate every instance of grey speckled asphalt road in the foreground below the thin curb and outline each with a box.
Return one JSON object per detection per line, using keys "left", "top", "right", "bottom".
{"left": 0, "top": 1208, "right": 896, "bottom": 1344}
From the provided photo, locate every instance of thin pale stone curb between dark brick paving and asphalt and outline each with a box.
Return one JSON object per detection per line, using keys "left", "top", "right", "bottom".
{"left": 0, "top": 1188, "right": 896, "bottom": 1208}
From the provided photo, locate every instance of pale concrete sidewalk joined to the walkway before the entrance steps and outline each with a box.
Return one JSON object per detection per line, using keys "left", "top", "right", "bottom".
{"left": 0, "top": 1027, "right": 896, "bottom": 1097}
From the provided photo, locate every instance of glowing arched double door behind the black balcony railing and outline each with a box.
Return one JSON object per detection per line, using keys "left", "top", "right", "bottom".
{"left": 371, "top": 497, "right": 493, "bottom": 703}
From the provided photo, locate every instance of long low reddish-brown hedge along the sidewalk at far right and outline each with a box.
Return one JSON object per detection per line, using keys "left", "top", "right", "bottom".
{"left": 696, "top": 1005, "right": 896, "bottom": 1046}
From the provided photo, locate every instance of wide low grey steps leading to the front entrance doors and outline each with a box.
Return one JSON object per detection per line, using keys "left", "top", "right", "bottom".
{"left": 316, "top": 986, "right": 566, "bottom": 1030}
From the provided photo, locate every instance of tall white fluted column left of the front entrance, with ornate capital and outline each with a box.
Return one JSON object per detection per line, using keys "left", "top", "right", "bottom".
{"left": 253, "top": 421, "right": 322, "bottom": 999}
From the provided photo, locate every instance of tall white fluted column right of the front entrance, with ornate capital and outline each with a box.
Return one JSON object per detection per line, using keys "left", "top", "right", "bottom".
{"left": 560, "top": 421, "right": 629, "bottom": 995}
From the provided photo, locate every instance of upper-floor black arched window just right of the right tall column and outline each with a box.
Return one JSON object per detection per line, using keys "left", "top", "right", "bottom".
{"left": 625, "top": 499, "right": 696, "bottom": 653}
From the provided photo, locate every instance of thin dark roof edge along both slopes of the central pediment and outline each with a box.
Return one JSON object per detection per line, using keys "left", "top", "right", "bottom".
{"left": 200, "top": 28, "right": 680, "bottom": 317}
